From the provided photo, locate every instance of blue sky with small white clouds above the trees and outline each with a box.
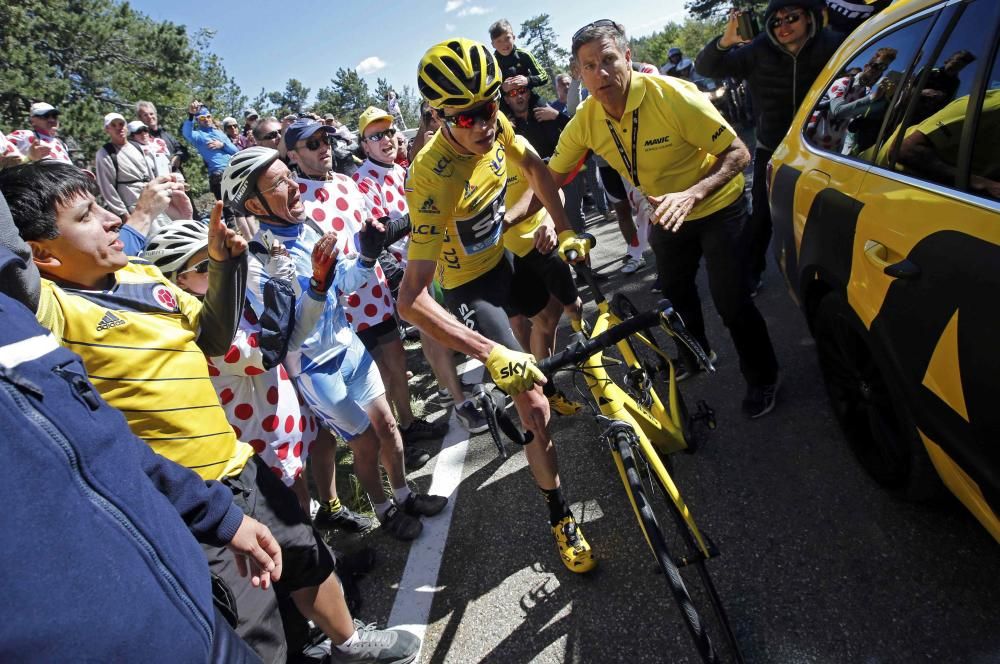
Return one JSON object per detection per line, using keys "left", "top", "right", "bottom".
{"left": 130, "top": 0, "right": 685, "bottom": 105}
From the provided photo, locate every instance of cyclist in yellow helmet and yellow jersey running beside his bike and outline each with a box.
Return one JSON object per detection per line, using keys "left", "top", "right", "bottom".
{"left": 397, "top": 39, "right": 596, "bottom": 572}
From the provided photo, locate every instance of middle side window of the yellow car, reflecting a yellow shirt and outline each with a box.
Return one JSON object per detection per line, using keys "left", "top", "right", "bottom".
{"left": 875, "top": 0, "right": 1000, "bottom": 187}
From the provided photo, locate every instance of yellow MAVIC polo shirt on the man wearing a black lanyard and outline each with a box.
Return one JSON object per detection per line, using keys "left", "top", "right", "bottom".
{"left": 549, "top": 71, "right": 743, "bottom": 219}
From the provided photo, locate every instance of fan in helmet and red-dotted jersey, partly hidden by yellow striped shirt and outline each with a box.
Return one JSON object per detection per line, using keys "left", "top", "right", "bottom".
{"left": 147, "top": 220, "right": 324, "bottom": 512}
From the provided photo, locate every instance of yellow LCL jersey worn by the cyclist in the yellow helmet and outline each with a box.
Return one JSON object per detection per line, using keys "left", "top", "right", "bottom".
{"left": 405, "top": 113, "right": 525, "bottom": 289}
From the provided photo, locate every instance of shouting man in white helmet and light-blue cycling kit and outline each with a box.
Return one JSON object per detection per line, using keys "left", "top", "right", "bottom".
{"left": 222, "top": 144, "right": 448, "bottom": 540}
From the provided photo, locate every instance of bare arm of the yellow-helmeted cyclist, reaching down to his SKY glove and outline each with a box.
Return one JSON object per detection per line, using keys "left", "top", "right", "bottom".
{"left": 396, "top": 260, "right": 496, "bottom": 362}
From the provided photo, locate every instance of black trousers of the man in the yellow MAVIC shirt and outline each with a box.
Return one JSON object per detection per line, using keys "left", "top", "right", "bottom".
{"left": 649, "top": 196, "right": 778, "bottom": 385}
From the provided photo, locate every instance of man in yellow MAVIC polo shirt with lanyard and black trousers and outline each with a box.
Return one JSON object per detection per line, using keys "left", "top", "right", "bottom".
{"left": 549, "top": 19, "right": 778, "bottom": 418}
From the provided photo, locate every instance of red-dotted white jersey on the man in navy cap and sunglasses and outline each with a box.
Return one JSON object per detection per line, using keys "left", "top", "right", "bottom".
{"left": 297, "top": 173, "right": 394, "bottom": 332}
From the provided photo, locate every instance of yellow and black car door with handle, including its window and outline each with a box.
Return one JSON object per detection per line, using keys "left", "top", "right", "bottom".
{"left": 849, "top": 0, "right": 1000, "bottom": 539}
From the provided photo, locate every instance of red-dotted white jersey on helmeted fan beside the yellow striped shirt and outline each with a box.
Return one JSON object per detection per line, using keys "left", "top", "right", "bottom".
{"left": 201, "top": 304, "right": 319, "bottom": 486}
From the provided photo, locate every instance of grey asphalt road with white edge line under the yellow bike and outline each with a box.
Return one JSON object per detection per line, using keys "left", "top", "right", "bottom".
{"left": 340, "top": 205, "right": 1000, "bottom": 663}
